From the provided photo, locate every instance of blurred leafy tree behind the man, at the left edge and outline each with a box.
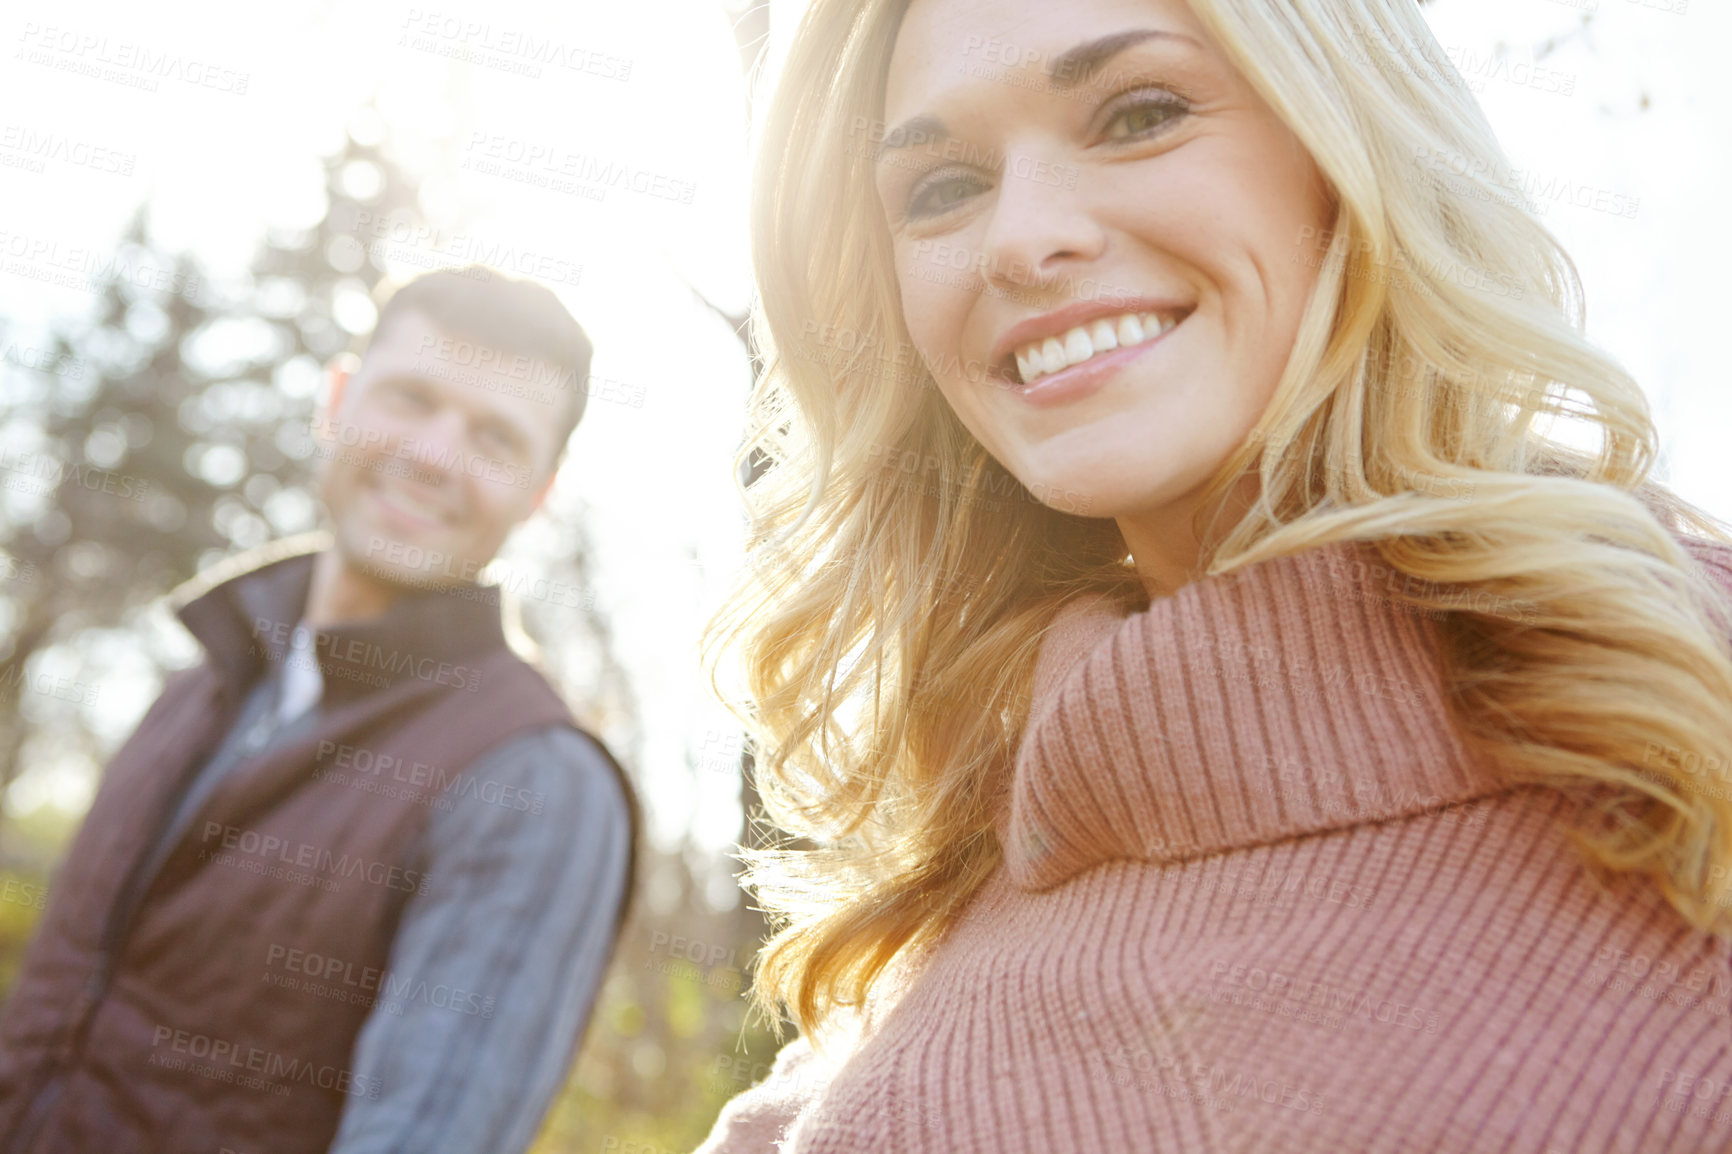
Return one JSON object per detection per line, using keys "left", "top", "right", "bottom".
{"left": 0, "top": 123, "right": 414, "bottom": 862}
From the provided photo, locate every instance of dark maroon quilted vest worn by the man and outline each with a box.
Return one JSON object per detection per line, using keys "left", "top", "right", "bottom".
{"left": 0, "top": 541, "right": 636, "bottom": 1154}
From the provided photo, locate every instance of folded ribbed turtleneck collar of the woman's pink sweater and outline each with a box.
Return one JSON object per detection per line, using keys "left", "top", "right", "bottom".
{"left": 998, "top": 546, "right": 1507, "bottom": 891}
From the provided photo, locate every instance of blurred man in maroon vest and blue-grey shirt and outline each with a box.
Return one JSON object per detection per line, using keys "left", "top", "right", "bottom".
{"left": 0, "top": 269, "right": 637, "bottom": 1154}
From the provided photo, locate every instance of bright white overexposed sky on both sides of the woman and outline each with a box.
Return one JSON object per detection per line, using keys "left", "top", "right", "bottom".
{"left": 0, "top": 0, "right": 1732, "bottom": 866}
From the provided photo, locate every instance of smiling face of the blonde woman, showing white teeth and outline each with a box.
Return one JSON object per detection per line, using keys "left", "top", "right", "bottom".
{"left": 876, "top": 0, "right": 1332, "bottom": 565}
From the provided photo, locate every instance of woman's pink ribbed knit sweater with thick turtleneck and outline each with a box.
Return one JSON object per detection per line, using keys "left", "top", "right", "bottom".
{"left": 701, "top": 546, "right": 1732, "bottom": 1154}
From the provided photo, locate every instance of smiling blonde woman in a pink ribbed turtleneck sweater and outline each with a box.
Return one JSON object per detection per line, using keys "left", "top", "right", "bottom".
{"left": 703, "top": 0, "right": 1732, "bottom": 1154}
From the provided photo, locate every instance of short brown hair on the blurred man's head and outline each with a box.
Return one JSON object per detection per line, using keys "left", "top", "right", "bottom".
{"left": 357, "top": 265, "right": 594, "bottom": 463}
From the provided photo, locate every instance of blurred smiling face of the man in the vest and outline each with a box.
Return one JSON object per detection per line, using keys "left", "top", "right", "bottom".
{"left": 313, "top": 312, "right": 577, "bottom": 587}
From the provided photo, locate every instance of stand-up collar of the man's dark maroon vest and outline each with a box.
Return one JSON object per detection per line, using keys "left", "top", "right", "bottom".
{"left": 173, "top": 532, "right": 507, "bottom": 703}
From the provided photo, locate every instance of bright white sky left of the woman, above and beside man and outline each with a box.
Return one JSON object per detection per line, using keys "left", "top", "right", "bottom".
{"left": 0, "top": 0, "right": 748, "bottom": 862}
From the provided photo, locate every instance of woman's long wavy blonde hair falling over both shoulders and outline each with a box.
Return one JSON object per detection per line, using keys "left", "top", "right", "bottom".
{"left": 705, "top": 0, "right": 1732, "bottom": 1034}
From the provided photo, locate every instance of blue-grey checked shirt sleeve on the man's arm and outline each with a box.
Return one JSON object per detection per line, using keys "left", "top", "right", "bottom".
{"left": 331, "top": 726, "right": 630, "bottom": 1154}
